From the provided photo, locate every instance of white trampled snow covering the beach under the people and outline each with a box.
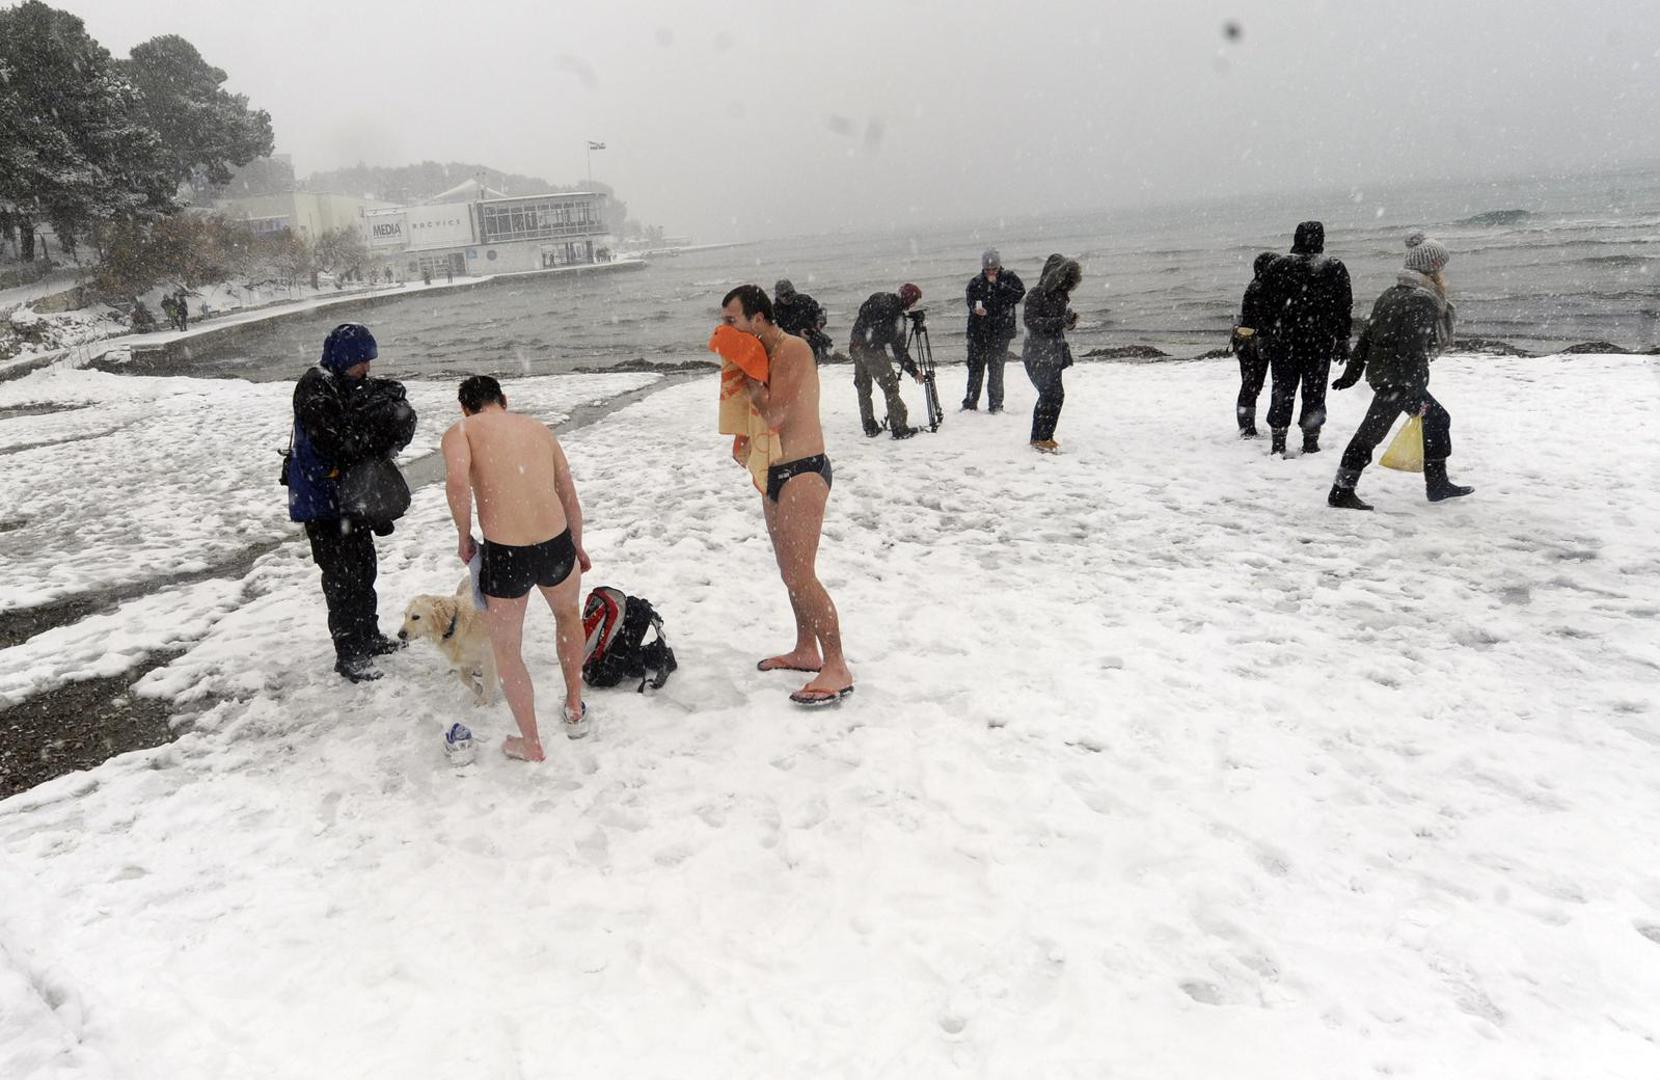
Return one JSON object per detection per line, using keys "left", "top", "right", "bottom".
{"left": 0, "top": 357, "right": 1660, "bottom": 1078}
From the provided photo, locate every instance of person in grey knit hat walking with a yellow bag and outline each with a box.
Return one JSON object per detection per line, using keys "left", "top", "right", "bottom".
{"left": 1326, "top": 232, "right": 1476, "bottom": 509}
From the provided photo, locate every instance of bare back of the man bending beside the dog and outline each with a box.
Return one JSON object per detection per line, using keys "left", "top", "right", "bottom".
{"left": 457, "top": 408, "right": 566, "bottom": 547}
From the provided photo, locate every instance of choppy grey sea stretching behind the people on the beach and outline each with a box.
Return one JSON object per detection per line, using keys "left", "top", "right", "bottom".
{"left": 168, "top": 173, "right": 1660, "bottom": 380}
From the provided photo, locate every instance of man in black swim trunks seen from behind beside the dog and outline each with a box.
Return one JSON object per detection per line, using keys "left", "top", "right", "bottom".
{"left": 442, "top": 375, "right": 593, "bottom": 761}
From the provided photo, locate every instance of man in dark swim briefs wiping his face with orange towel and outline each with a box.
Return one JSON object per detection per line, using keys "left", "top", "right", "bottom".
{"left": 720, "top": 285, "right": 853, "bottom": 708}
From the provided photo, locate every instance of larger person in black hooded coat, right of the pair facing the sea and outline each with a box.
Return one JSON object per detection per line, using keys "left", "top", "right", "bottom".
{"left": 1257, "top": 221, "right": 1355, "bottom": 455}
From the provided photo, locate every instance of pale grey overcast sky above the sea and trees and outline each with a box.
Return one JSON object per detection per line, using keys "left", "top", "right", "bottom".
{"left": 51, "top": 0, "right": 1660, "bottom": 241}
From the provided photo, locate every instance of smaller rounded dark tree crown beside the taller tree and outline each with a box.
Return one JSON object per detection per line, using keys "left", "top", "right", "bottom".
{"left": 118, "top": 33, "right": 272, "bottom": 186}
